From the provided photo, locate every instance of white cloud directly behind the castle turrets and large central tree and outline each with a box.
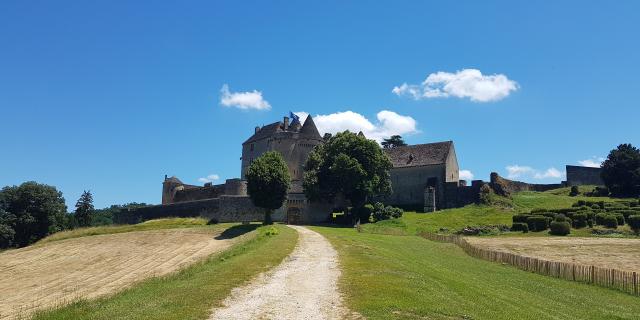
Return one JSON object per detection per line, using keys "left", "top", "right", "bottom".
{"left": 295, "top": 110, "right": 418, "bottom": 142}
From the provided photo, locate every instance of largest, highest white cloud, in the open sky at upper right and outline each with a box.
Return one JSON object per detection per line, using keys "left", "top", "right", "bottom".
{"left": 392, "top": 69, "right": 518, "bottom": 102}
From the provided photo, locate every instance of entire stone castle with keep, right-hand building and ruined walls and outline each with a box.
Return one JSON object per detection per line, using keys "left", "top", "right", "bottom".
{"left": 119, "top": 116, "right": 600, "bottom": 224}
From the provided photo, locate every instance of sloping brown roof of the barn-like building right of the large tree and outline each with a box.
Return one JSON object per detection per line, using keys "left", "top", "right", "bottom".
{"left": 384, "top": 141, "right": 453, "bottom": 168}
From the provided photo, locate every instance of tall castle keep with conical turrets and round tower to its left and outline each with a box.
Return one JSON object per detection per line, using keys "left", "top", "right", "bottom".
{"left": 153, "top": 116, "right": 331, "bottom": 223}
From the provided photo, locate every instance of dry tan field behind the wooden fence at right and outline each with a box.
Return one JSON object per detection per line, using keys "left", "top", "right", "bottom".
{"left": 466, "top": 237, "right": 640, "bottom": 271}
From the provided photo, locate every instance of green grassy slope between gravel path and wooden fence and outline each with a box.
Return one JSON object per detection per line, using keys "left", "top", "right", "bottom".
{"left": 314, "top": 227, "right": 640, "bottom": 319}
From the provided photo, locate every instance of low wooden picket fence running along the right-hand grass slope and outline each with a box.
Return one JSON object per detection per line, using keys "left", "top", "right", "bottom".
{"left": 421, "top": 232, "right": 640, "bottom": 296}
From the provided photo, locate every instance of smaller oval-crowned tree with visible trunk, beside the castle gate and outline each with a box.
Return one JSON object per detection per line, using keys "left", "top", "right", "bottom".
{"left": 246, "top": 151, "right": 291, "bottom": 224}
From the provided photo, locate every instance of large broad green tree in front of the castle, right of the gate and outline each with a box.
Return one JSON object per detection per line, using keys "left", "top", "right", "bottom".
{"left": 303, "top": 131, "right": 392, "bottom": 215}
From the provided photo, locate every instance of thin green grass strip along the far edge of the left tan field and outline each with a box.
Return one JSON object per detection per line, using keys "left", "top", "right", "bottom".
{"left": 36, "top": 218, "right": 212, "bottom": 245}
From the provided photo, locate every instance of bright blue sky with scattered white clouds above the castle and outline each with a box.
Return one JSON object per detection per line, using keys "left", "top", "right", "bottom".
{"left": 0, "top": 1, "right": 640, "bottom": 207}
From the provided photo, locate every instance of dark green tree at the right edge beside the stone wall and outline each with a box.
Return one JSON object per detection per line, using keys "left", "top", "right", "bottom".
{"left": 602, "top": 143, "right": 640, "bottom": 197}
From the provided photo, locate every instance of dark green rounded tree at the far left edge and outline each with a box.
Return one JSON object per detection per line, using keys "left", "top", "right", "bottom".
{"left": 0, "top": 181, "right": 67, "bottom": 247}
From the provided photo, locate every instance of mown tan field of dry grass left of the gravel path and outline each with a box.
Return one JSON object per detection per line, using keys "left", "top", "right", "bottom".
{"left": 0, "top": 227, "right": 244, "bottom": 319}
